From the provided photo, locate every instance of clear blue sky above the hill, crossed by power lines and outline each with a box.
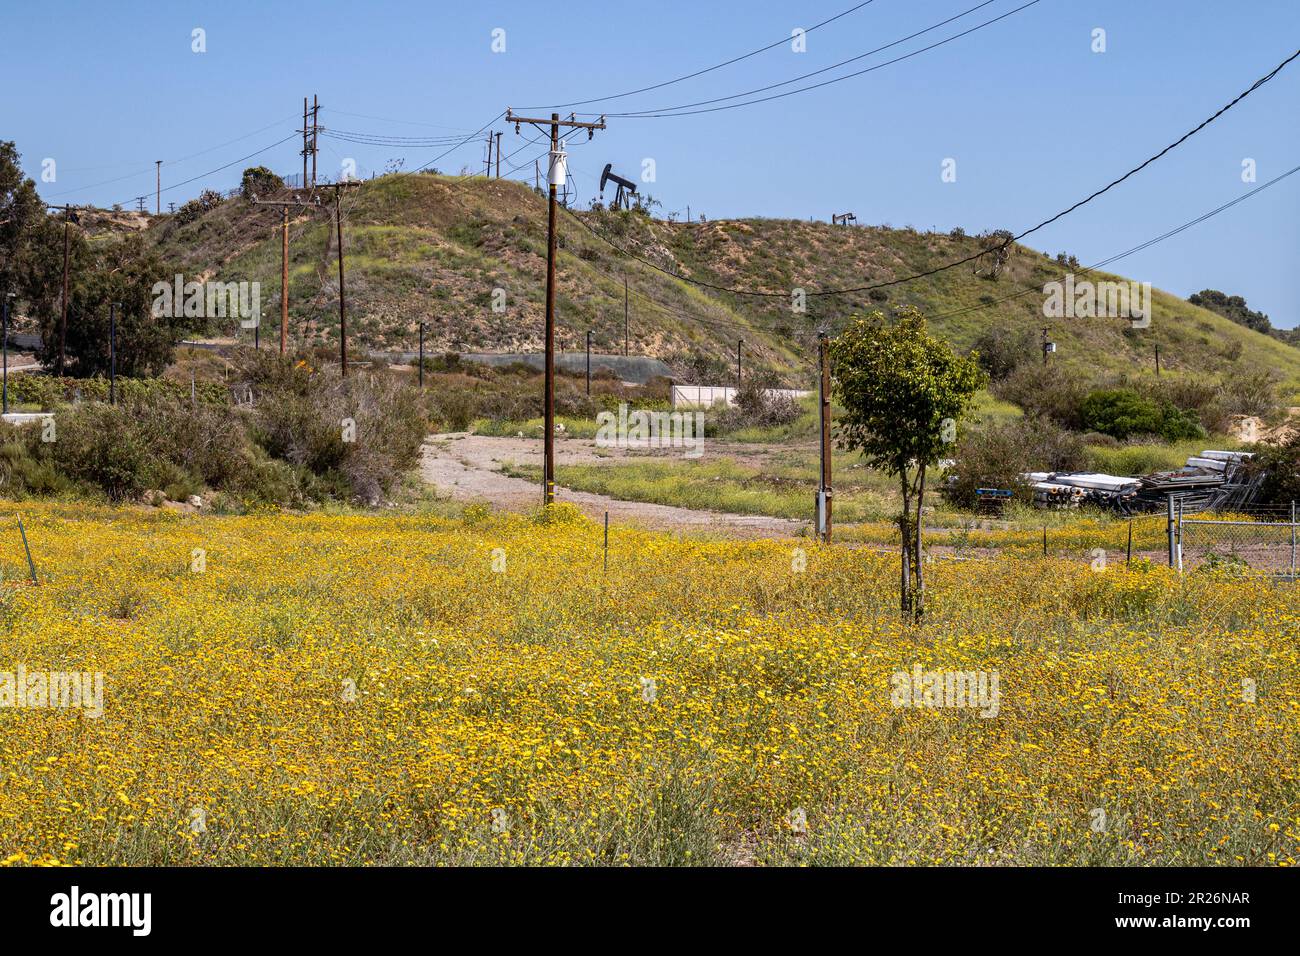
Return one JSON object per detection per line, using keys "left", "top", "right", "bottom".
{"left": 0, "top": 0, "right": 1300, "bottom": 326}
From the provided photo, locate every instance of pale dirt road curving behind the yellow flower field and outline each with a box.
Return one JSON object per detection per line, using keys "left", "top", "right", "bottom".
{"left": 420, "top": 432, "right": 807, "bottom": 537}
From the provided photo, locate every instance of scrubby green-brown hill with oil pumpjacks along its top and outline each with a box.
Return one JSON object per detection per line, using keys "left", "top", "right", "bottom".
{"left": 148, "top": 174, "right": 1300, "bottom": 389}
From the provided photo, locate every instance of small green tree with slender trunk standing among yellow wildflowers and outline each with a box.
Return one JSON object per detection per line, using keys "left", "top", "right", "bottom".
{"left": 831, "top": 307, "right": 987, "bottom": 620}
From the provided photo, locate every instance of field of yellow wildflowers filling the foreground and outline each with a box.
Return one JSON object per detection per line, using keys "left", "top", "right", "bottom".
{"left": 0, "top": 503, "right": 1300, "bottom": 865}
